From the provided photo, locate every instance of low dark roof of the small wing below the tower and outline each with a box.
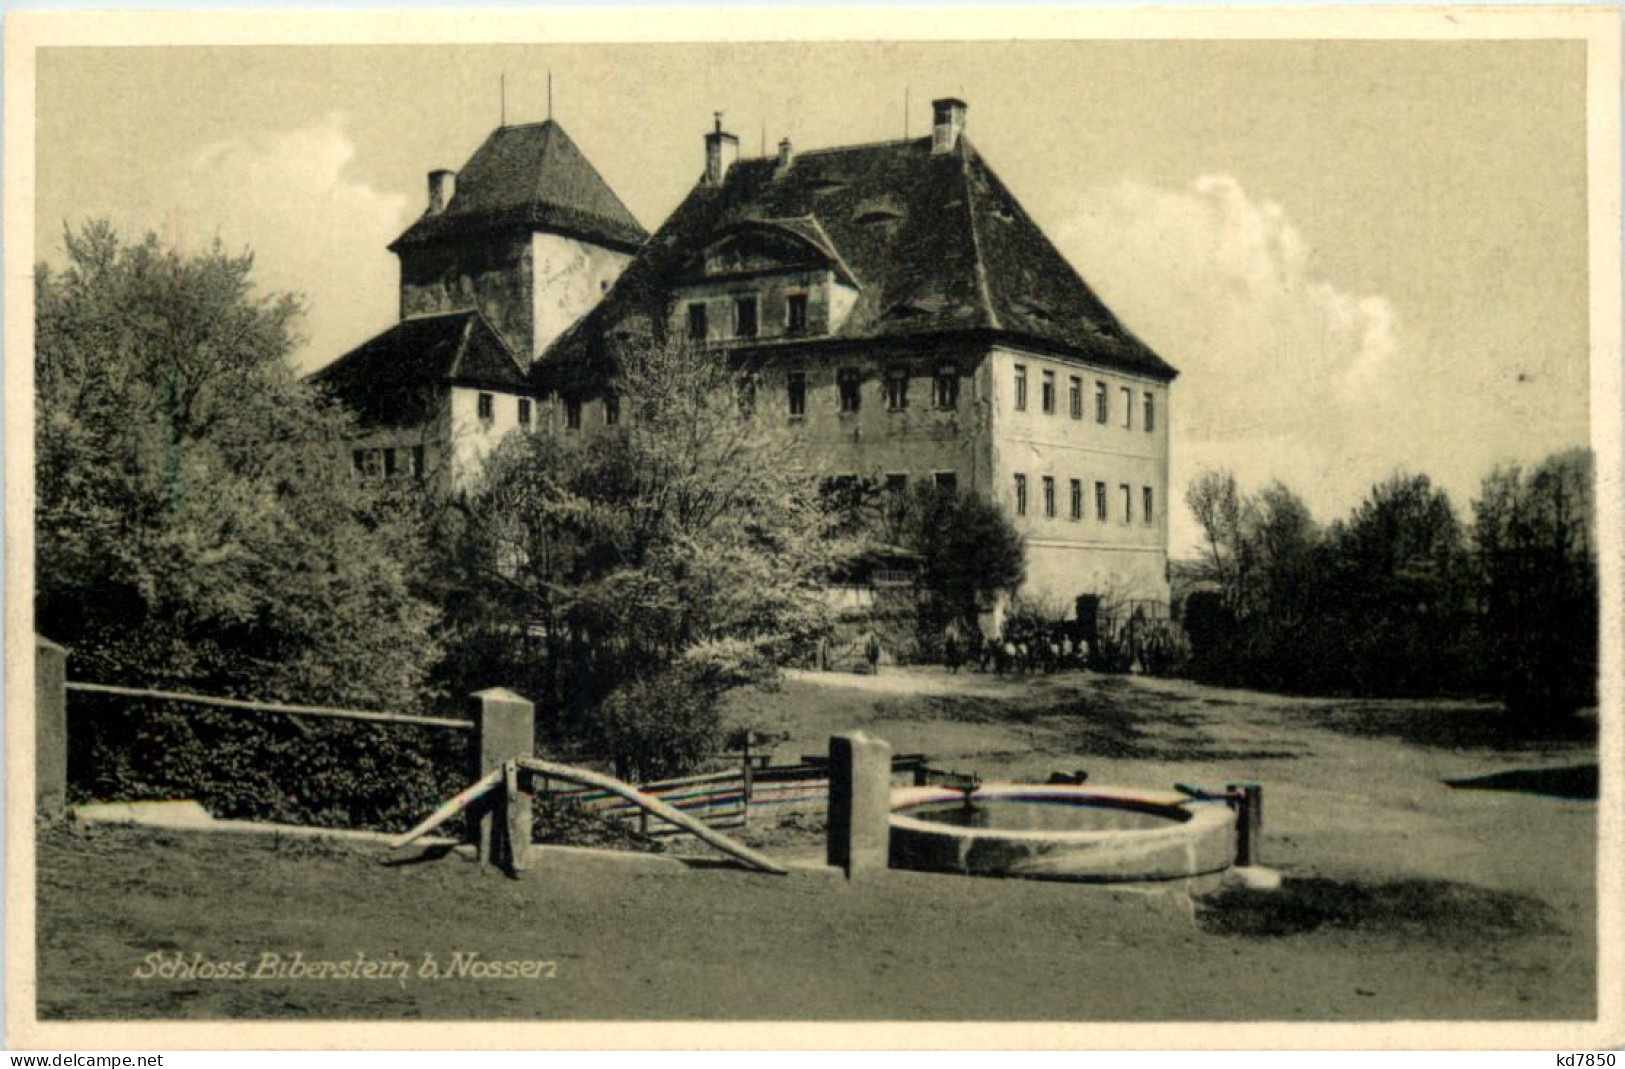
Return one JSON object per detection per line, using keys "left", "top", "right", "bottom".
{"left": 309, "top": 309, "right": 525, "bottom": 426}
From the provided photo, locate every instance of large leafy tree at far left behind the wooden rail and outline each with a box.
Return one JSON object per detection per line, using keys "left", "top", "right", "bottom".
{"left": 36, "top": 223, "right": 434, "bottom": 708}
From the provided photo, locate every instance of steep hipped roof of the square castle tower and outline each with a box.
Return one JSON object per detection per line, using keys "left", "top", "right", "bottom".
{"left": 390, "top": 119, "right": 648, "bottom": 252}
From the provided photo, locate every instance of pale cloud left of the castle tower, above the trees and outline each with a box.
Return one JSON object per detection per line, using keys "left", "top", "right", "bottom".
{"left": 171, "top": 112, "right": 410, "bottom": 370}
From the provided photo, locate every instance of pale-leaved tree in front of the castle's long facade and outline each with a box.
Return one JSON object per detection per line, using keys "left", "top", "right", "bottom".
{"left": 453, "top": 333, "right": 829, "bottom": 777}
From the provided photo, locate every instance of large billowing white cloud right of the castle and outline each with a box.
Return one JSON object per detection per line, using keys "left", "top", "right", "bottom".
{"left": 1055, "top": 175, "right": 1417, "bottom": 554}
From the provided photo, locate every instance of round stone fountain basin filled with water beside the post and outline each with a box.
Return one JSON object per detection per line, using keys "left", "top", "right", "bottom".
{"left": 891, "top": 783, "right": 1235, "bottom": 884}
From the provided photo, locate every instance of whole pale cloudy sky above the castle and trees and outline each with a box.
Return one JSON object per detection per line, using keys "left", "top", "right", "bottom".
{"left": 36, "top": 41, "right": 1589, "bottom": 556}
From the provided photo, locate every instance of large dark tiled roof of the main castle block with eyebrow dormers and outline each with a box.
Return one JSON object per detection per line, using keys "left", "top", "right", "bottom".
{"left": 533, "top": 130, "right": 1178, "bottom": 382}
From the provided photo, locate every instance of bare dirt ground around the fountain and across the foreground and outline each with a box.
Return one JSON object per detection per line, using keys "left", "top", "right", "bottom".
{"left": 28, "top": 668, "right": 1596, "bottom": 1020}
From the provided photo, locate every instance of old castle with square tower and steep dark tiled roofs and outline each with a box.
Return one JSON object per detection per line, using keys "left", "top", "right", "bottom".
{"left": 317, "top": 99, "right": 1178, "bottom": 617}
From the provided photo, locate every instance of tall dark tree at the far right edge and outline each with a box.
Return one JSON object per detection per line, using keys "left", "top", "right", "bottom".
{"left": 1472, "top": 450, "right": 1597, "bottom": 715}
